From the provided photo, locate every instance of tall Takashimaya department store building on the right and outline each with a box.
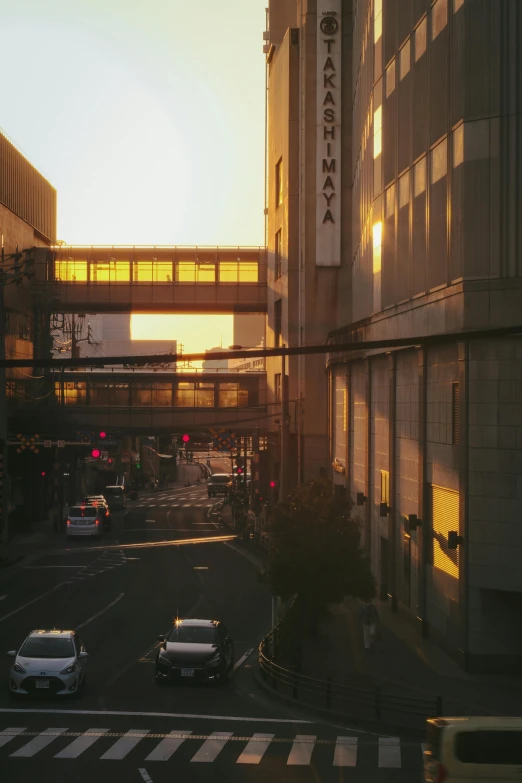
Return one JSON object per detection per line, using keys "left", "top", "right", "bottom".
{"left": 266, "top": 0, "right": 522, "bottom": 671}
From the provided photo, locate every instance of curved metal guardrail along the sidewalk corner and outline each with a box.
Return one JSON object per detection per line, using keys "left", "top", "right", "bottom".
{"left": 259, "top": 626, "right": 442, "bottom": 723}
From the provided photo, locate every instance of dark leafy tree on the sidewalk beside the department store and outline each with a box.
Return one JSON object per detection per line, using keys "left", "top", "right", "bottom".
{"left": 267, "top": 479, "right": 375, "bottom": 611}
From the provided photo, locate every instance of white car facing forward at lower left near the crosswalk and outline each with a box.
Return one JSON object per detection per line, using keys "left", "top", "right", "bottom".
{"left": 7, "top": 629, "right": 88, "bottom": 696}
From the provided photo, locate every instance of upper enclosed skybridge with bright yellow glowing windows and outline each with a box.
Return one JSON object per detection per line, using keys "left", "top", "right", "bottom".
{"left": 31, "top": 246, "right": 267, "bottom": 313}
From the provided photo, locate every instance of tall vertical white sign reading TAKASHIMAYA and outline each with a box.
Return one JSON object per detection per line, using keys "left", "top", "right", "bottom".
{"left": 315, "top": 0, "right": 342, "bottom": 266}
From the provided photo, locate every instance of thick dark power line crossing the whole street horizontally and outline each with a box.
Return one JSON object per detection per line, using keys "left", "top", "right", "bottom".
{"left": 0, "top": 326, "right": 522, "bottom": 368}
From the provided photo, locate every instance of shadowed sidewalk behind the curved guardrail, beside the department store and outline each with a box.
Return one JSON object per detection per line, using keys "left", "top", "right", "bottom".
{"left": 296, "top": 599, "right": 522, "bottom": 715}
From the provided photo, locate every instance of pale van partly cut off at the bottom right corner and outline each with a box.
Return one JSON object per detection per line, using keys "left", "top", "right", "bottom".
{"left": 423, "top": 717, "right": 522, "bottom": 783}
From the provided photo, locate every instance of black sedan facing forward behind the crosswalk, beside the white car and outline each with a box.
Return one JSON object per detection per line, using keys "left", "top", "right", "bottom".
{"left": 156, "top": 620, "right": 234, "bottom": 684}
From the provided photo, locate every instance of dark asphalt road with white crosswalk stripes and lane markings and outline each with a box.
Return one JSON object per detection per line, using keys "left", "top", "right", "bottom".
{"left": 0, "top": 462, "right": 421, "bottom": 783}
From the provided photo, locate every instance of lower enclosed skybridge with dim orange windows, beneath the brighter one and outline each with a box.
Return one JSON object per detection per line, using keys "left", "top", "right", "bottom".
{"left": 6, "top": 370, "right": 267, "bottom": 435}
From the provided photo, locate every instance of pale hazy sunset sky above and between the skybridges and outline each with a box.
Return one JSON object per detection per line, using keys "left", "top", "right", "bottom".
{"left": 0, "top": 0, "right": 266, "bottom": 350}
